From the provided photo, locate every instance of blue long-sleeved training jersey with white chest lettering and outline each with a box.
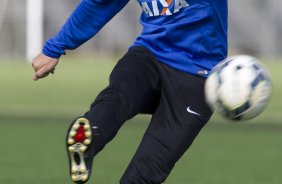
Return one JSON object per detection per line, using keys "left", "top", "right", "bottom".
{"left": 43, "top": 0, "right": 228, "bottom": 77}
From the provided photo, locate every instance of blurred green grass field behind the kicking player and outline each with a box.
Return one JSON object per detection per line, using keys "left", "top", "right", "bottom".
{"left": 0, "top": 59, "right": 282, "bottom": 184}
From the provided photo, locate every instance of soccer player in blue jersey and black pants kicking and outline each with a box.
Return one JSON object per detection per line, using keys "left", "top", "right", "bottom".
{"left": 32, "top": 0, "right": 227, "bottom": 184}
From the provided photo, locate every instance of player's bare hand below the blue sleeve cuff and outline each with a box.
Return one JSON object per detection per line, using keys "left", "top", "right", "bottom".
{"left": 32, "top": 53, "right": 59, "bottom": 81}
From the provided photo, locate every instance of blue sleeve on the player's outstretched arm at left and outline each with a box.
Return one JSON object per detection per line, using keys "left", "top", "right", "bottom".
{"left": 42, "top": 0, "right": 129, "bottom": 58}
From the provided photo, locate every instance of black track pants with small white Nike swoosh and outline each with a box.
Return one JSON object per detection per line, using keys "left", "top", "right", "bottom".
{"left": 82, "top": 47, "right": 212, "bottom": 184}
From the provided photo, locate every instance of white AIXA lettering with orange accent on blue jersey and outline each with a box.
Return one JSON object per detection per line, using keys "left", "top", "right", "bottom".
{"left": 140, "top": 0, "right": 189, "bottom": 17}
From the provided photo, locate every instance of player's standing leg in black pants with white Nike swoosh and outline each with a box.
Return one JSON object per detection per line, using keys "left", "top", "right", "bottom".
{"left": 120, "top": 64, "right": 212, "bottom": 184}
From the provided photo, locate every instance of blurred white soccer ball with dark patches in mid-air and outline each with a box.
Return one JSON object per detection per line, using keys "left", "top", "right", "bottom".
{"left": 205, "top": 55, "right": 272, "bottom": 120}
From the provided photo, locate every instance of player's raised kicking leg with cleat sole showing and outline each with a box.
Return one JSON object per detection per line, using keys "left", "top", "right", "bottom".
{"left": 64, "top": 48, "right": 160, "bottom": 183}
